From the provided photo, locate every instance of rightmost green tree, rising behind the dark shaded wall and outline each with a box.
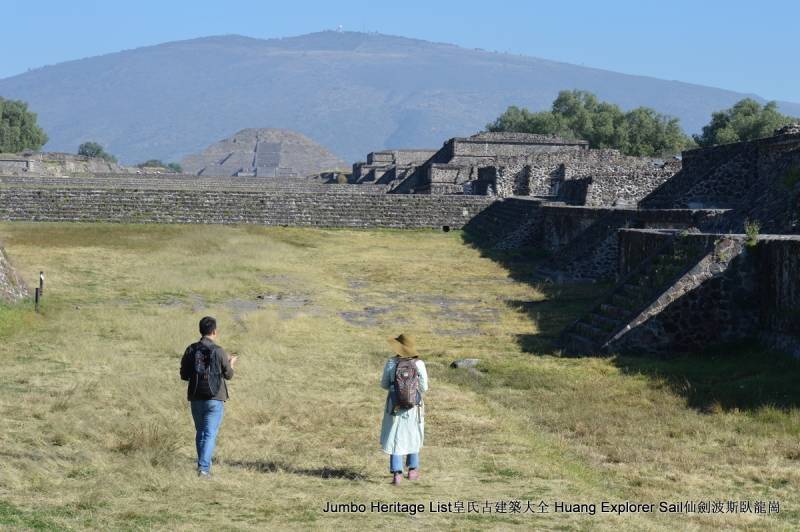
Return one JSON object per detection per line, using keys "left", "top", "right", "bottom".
{"left": 694, "top": 98, "right": 800, "bottom": 147}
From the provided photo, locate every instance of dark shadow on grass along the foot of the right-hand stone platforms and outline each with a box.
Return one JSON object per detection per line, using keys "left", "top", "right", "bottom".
{"left": 462, "top": 227, "right": 800, "bottom": 413}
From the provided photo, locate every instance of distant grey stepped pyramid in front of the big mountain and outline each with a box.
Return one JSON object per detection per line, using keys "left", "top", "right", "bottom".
{"left": 181, "top": 129, "right": 347, "bottom": 177}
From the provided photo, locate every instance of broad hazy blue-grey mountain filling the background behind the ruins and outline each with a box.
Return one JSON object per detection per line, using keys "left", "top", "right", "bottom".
{"left": 0, "top": 31, "right": 800, "bottom": 164}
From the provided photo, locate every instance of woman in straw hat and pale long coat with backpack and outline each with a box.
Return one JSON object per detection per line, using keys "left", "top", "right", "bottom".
{"left": 381, "top": 334, "right": 428, "bottom": 485}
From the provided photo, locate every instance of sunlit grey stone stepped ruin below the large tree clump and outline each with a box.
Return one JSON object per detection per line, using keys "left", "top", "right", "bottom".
{"left": 351, "top": 132, "right": 680, "bottom": 202}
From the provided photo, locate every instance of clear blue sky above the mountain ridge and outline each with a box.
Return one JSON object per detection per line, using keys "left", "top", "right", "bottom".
{"left": 0, "top": 0, "right": 800, "bottom": 102}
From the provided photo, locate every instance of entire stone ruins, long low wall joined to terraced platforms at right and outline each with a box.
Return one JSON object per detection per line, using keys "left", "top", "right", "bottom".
{"left": 0, "top": 126, "right": 800, "bottom": 356}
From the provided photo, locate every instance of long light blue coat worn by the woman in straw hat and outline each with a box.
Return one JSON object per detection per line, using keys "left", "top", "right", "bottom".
{"left": 381, "top": 357, "right": 428, "bottom": 455}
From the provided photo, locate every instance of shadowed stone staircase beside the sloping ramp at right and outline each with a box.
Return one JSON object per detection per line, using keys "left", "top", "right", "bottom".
{"left": 561, "top": 233, "right": 714, "bottom": 355}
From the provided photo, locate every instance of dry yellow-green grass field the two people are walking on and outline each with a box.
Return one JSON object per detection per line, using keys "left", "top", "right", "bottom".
{"left": 0, "top": 223, "right": 800, "bottom": 530}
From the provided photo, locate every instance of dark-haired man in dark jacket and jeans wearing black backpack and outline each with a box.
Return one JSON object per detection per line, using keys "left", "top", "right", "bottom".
{"left": 181, "top": 316, "right": 238, "bottom": 478}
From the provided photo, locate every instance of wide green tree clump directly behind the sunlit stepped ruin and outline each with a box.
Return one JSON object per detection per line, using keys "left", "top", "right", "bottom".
{"left": 486, "top": 90, "right": 692, "bottom": 156}
